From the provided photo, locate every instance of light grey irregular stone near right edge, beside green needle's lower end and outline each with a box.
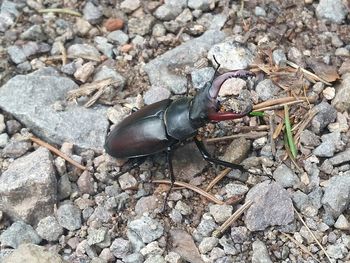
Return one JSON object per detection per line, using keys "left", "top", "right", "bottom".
{"left": 313, "top": 132, "right": 343, "bottom": 157}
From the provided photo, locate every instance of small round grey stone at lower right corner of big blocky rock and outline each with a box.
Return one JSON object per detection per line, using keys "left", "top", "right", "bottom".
{"left": 36, "top": 216, "right": 63, "bottom": 241}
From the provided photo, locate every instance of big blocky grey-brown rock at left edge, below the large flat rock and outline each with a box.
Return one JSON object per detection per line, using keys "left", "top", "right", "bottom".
{"left": 0, "top": 148, "right": 57, "bottom": 224}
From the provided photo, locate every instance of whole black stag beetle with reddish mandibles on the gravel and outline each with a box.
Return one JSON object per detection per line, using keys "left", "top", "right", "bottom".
{"left": 105, "top": 63, "right": 254, "bottom": 200}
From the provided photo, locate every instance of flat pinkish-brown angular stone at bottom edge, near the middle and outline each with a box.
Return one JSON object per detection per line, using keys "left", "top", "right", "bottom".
{"left": 170, "top": 229, "right": 203, "bottom": 263}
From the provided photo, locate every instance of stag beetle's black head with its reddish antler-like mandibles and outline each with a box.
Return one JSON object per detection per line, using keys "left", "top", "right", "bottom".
{"left": 190, "top": 70, "right": 255, "bottom": 128}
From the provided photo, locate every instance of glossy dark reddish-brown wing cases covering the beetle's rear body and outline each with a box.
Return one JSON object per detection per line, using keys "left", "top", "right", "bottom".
{"left": 105, "top": 100, "right": 176, "bottom": 158}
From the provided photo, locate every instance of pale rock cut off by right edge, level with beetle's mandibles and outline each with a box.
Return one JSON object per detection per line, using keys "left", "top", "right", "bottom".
{"left": 332, "top": 73, "right": 350, "bottom": 112}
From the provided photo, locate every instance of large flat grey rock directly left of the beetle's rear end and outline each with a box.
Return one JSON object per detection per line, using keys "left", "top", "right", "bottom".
{"left": 0, "top": 68, "right": 109, "bottom": 151}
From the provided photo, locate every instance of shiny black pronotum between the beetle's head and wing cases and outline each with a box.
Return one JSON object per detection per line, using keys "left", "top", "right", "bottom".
{"left": 164, "top": 98, "right": 197, "bottom": 141}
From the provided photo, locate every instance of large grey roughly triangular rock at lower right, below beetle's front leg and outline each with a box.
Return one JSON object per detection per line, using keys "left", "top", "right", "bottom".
{"left": 245, "top": 181, "right": 294, "bottom": 231}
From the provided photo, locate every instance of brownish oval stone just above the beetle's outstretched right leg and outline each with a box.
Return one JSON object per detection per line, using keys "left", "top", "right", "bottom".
{"left": 222, "top": 138, "right": 251, "bottom": 164}
